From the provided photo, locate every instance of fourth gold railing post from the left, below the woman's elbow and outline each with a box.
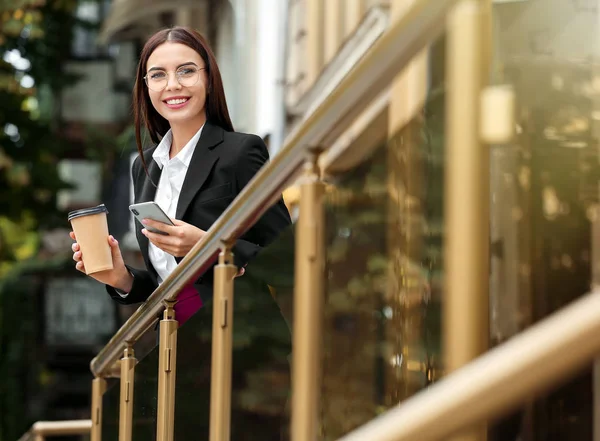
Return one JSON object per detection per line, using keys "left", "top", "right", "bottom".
{"left": 210, "top": 243, "right": 237, "bottom": 441}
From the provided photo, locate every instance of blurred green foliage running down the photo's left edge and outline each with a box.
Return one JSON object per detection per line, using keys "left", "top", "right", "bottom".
{"left": 0, "top": 0, "right": 84, "bottom": 441}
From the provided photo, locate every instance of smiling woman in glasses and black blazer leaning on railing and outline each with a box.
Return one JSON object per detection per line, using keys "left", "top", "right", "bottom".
{"left": 71, "top": 27, "right": 291, "bottom": 316}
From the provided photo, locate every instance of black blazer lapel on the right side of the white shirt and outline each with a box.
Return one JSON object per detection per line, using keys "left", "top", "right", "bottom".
{"left": 175, "top": 121, "right": 223, "bottom": 219}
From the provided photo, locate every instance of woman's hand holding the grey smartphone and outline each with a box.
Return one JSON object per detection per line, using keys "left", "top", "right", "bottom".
{"left": 142, "top": 219, "right": 206, "bottom": 257}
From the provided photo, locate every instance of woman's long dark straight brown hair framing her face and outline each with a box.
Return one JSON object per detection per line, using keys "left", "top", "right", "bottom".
{"left": 133, "top": 26, "right": 233, "bottom": 169}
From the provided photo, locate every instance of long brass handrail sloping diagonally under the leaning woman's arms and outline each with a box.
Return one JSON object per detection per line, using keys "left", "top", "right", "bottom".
{"left": 90, "top": 0, "right": 458, "bottom": 376}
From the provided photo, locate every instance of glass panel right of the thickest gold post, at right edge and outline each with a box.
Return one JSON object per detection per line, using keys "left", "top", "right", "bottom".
{"left": 490, "top": 0, "right": 600, "bottom": 441}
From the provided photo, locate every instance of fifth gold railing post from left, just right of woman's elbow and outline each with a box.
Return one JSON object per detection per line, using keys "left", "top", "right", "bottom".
{"left": 291, "top": 149, "right": 325, "bottom": 441}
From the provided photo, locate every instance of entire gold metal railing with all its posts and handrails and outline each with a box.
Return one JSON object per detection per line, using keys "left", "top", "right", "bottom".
{"left": 25, "top": 0, "right": 600, "bottom": 441}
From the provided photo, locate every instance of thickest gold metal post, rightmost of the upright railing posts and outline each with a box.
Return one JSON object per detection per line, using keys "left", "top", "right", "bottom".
{"left": 443, "top": 0, "right": 490, "bottom": 441}
